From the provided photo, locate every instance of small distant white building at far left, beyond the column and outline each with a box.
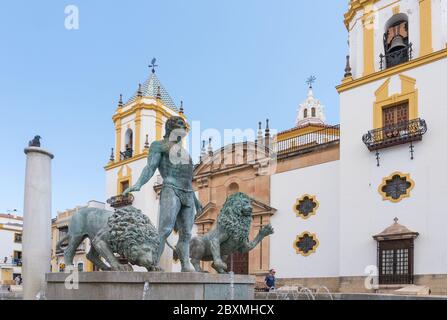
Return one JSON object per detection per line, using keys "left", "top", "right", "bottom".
{"left": 0, "top": 214, "right": 23, "bottom": 285}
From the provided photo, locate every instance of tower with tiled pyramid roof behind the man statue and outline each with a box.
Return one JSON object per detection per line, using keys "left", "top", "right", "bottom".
{"left": 105, "top": 59, "right": 185, "bottom": 232}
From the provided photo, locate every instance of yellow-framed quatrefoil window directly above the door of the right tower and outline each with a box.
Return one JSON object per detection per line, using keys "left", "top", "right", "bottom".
{"left": 379, "top": 172, "right": 414, "bottom": 203}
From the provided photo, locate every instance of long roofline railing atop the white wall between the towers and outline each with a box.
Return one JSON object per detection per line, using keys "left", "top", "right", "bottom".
{"left": 273, "top": 125, "right": 340, "bottom": 156}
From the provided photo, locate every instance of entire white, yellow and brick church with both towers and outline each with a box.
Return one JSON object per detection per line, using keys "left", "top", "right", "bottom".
{"left": 105, "top": 0, "right": 447, "bottom": 294}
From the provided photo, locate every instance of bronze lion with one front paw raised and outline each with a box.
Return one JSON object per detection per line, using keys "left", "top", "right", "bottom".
{"left": 184, "top": 192, "right": 273, "bottom": 273}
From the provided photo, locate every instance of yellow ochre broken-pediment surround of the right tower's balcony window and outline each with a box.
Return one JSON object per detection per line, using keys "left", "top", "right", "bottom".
{"left": 373, "top": 75, "right": 419, "bottom": 129}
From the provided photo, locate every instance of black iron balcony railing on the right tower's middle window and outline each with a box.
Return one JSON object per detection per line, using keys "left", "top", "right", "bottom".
{"left": 362, "top": 119, "right": 427, "bottom": 151}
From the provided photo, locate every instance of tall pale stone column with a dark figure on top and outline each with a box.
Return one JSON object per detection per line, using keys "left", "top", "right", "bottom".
{"left": 22, "top": 147, "right": 54, "bottom": 300}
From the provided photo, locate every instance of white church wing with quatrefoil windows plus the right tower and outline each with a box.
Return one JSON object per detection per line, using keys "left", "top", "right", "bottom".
{"left": 270, "top": 0, "right": 447, "bottom": 294}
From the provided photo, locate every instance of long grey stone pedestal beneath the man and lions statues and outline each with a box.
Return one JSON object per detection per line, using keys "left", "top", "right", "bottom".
{"left": 46, "top": 272, "right": 255, "bottom": 300}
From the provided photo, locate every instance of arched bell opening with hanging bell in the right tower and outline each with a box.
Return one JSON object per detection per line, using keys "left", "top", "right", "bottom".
{"left": 380, "top": 13, "right": 412, "bottom": 69}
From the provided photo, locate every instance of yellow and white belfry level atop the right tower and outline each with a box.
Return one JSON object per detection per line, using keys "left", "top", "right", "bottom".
{"left": 344, "top": 0, "right": 447, "bottom": 79}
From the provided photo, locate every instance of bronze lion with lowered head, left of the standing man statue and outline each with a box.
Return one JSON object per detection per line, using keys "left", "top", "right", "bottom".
{"left": 57, "top": 206, "right": 160, "bottom": 271}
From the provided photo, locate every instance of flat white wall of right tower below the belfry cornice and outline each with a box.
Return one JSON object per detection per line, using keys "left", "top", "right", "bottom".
{"left": 340, "top": 59, "right": 447, "bottom": 276}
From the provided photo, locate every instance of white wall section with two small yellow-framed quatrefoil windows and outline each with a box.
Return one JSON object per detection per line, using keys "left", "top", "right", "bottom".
{"left": 270, "top": 161, "right": 339, "bottom": 278}
